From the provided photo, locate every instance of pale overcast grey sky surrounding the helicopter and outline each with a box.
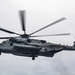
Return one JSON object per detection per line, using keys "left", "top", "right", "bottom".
{"left": 0, "top": 0, "right": 75, "bottom": 75}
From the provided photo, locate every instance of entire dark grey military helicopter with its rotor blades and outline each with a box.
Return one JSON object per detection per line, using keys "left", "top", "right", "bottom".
{"left": 0, "top": 10, "right": 75, "bottom": 60}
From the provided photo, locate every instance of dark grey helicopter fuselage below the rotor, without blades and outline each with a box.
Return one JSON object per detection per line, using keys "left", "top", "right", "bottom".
{"left": 0, "top": 37, "right": 75, "bottom": 60}
